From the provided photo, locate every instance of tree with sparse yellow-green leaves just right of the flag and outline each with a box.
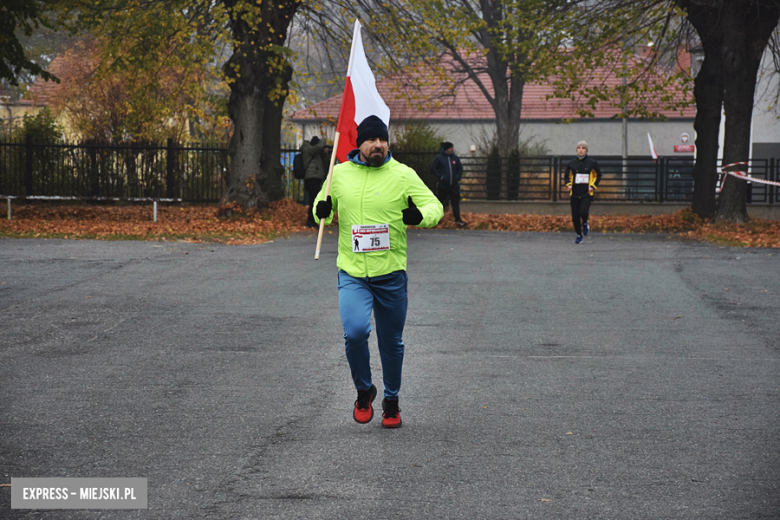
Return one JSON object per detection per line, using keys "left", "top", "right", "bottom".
{"left": 304, "top": 0, "right": 576, "bottom": 154}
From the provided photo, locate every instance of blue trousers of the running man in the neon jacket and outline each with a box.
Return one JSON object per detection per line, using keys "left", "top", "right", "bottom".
{"left": 339, "top": 271, "right": 408, "bottom": 399}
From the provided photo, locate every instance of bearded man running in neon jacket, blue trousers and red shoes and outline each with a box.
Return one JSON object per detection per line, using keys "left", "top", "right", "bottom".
{"left": 315, "top": 116, "right": 443, "bottom": 428}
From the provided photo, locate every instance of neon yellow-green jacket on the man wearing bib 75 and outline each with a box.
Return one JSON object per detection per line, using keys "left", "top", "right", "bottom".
{"left": 314, "top": 150, "right": 444, "bottom": 278}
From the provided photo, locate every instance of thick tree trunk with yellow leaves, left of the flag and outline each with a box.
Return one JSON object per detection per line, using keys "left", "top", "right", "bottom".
{"left": 222, "top": 0, "right": 300, "bottom": 212}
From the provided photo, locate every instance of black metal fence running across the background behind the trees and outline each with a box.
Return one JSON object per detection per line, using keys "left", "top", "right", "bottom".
{"left": 0, "top": 140, "right": 780, "bottom": 204}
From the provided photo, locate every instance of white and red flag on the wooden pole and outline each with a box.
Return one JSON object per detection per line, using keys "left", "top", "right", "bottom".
{"left": 336, "top": 20, "right": 390, "bottom": 162}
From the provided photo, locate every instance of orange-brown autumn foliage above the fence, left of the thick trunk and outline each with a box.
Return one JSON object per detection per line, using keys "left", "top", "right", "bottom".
{"left": 48, "top": 39, "right": 226, "bottom": 143}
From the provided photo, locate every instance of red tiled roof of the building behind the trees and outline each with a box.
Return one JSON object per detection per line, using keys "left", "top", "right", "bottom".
{"left": 289, "top": 51, "right": 695, "bottom": 123}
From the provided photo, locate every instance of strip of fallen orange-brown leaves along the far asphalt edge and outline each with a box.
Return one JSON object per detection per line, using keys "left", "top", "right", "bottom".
{"left": 0, "top": 199, "right": 780, "bottom": 247}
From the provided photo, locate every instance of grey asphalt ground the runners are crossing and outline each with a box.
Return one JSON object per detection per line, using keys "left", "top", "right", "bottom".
{"left": 0, "top": 230, "right": 780, "bottom": 520}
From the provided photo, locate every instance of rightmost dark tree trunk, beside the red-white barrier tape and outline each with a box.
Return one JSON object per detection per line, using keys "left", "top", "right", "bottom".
{"left": 715, "top": 0, "right": 780, "bottom": 223}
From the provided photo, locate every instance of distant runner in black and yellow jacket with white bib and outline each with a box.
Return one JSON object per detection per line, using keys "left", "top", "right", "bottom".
{"left": 566, "top": 141, "right": 601, "bottom": 244}
